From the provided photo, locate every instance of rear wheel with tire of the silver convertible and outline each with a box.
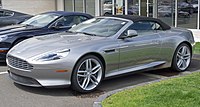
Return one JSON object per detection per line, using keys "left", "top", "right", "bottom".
{"left": 171, "top": 43, "right": 192, "bottom": 72}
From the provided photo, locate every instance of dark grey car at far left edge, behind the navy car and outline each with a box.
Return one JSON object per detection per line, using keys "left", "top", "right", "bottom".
{"left": 0, "top": 9, "right": 32, "bottom": 27}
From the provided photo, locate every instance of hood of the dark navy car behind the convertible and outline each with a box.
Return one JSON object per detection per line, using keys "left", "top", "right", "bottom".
{"left": 0, "top": 24, "right": 39, "bottom": 35}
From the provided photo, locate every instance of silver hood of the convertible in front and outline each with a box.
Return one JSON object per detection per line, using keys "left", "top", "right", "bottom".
{"left": 8, "top": 33, "right": 105, "bottom": 59}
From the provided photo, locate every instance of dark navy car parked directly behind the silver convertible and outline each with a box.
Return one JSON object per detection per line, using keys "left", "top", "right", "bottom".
{"left": 0, "top": 11, "right": 93, "bottom": 62}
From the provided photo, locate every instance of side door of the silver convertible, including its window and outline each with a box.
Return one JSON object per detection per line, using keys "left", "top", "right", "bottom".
{"left": 119, "top": 21, "right": 161, "bottom": 70}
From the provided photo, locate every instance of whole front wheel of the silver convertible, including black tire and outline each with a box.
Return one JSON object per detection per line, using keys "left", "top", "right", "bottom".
{"left": 71, "top": 55, "right": 104, "bottom": 93}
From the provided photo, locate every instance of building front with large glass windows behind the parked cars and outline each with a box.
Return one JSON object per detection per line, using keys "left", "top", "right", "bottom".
{"left": 0, "top": 0, "right": 200, "bottom": 29}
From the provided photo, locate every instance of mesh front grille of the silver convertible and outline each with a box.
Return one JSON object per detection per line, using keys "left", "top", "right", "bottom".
{"left": 8, "top": 56, "right": 33, "bottom": 70}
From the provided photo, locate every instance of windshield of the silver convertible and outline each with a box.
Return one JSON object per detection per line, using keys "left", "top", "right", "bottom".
{"left": 69, "top": 18, "right": 127, "bottom": 37}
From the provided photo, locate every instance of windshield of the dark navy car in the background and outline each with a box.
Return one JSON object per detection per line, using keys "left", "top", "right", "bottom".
{"left": 21, "top": 14, "right": 59, "bottom": 27}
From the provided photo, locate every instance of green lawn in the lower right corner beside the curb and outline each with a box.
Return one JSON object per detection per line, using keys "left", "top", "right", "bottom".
{"left": 102, "top": 72, "right": 200, "bottom": 107}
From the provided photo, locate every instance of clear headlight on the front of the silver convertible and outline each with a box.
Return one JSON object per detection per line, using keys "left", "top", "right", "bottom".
{"left": 34, "top": 49, "right": 70, "bottom": 62}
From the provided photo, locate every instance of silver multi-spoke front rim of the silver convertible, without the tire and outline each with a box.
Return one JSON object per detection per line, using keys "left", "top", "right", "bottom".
{"left": 77, "top": 58, "right": 103, "bottom": 91}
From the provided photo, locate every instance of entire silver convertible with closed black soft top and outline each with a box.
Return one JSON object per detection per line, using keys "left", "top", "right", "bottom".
{"left": 7, "top": 15, "right": 195, "bottom": 93}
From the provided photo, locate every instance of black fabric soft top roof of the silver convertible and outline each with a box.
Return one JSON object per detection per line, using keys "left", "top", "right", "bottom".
{"left": 110, "top": 15, "right": 171, "bottom": 30}
